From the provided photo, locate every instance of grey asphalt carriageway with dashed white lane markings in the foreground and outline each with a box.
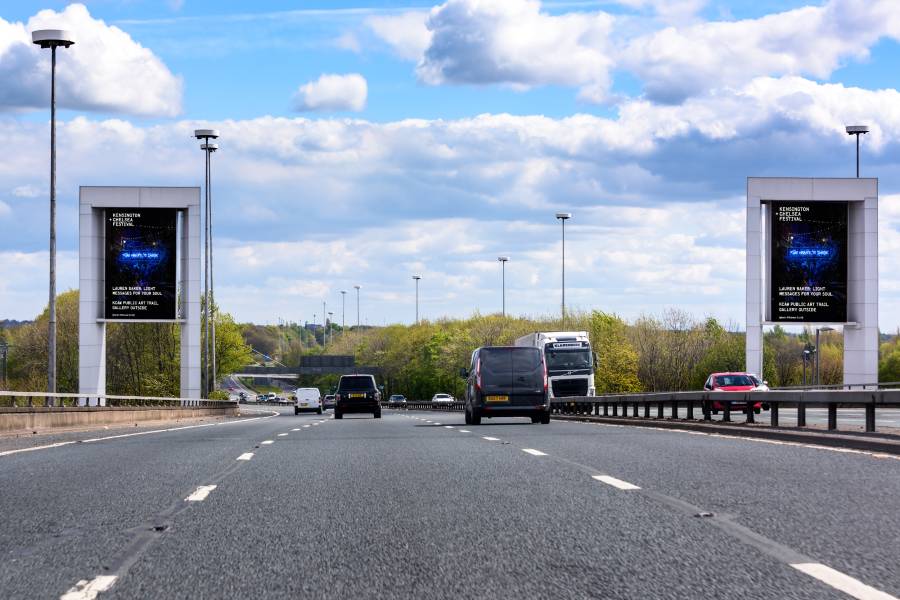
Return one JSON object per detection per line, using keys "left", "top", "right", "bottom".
{"left": 0, "top": 409, "right": 900, "bottom": 600}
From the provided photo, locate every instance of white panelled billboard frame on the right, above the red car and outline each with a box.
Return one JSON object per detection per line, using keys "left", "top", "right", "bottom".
{"left": 746, "top": 177, "right": 878, "bottom": 385}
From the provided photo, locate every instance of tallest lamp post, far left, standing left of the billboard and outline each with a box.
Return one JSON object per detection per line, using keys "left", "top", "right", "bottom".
{"left": 31, "top": 29, "right": 75, "bottom": 404}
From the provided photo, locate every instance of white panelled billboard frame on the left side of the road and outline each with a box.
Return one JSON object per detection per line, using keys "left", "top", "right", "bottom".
{"left": 78, "top": 186, "right": 201, "bottom": 401}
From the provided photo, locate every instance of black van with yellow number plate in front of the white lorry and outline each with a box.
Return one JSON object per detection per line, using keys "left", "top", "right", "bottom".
{"left": 460, "top": 346, "right": 550, "bottom": 425}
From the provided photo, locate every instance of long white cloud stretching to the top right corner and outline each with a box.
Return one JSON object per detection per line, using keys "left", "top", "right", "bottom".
{"left": 619, "top": 0, "right": 900, "bottom": 102}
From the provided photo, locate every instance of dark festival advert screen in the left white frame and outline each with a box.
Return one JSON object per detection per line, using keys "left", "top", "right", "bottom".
{"left": 104, "top": 208, "right": 178, "bottom": 320}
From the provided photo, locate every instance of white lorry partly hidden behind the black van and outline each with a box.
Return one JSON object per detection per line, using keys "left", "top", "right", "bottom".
{"left": 516, "top": 331, "right": 597, "bottom": 398}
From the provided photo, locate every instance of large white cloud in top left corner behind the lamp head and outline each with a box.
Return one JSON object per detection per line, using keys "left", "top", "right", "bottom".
{"left": 0, "top": 4, "right": 182, "bottom": 116}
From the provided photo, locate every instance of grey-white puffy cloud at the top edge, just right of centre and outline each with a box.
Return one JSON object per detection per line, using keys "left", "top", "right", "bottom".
{"left": 417, "top": 0, "right": 614, "bottom": 102}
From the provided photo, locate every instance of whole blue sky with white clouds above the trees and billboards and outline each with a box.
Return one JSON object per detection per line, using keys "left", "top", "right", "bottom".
{"left": 0, "top": 0, "right": 900, "bottom": 330}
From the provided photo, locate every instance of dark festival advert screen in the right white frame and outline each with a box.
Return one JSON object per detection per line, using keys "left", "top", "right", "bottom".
{"left": 770, "top": 202, "right": 848, "bottom": 323}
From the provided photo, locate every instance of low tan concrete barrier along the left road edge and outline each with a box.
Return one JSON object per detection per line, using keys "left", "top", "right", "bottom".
{"left": 0, "top": 404, "right": 238, "bottom": 433}
